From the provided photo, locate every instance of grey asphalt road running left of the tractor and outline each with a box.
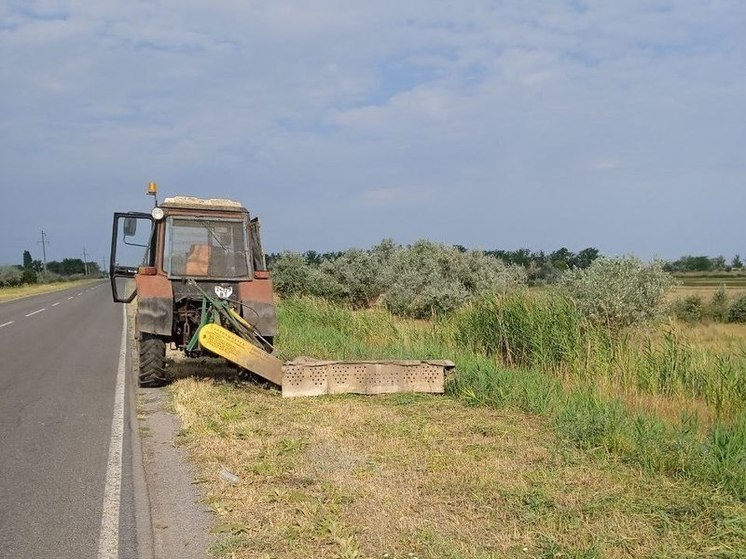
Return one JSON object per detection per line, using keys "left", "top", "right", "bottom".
{"left": 0, "top": 282, "right": 138, "bottom": 559}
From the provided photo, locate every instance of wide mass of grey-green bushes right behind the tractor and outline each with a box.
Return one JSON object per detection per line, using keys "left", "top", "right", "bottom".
{"left": 272, "top": 240, "right": 526, "bottom": 318}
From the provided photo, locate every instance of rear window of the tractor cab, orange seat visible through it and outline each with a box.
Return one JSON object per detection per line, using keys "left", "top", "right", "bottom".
{"left": 164, "top": 217, "right": 249, "bottom": 279}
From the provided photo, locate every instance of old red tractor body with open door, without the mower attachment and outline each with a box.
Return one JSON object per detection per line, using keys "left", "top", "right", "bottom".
{"left": 110, "top": 183, "right": 277, "bottom": 386}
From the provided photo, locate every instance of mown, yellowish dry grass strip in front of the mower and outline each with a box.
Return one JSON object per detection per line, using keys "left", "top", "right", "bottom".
{"left": 172, "top": 378, "right": 746, "bottom": 559}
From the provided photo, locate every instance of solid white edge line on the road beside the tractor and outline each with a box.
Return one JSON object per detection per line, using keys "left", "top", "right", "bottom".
{"left": 97, "top": 305, "right": 127, "bottom": 559}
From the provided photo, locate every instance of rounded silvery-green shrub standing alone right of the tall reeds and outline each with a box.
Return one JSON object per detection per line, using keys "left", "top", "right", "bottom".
{"left": 560, "top": 256, "right": 676, "bottom": 329}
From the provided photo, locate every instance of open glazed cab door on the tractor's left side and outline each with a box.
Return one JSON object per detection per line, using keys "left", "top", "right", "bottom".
{"left": 109, "top": 212, "right": 155, "bottom": 303}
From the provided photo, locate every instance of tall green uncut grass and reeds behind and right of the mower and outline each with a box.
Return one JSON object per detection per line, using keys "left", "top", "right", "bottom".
{"left": 278, "top": 293, "right": 746, "bottom": 500}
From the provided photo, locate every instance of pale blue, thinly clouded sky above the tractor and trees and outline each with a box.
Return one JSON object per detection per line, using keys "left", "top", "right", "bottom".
{"left": 0, "top": 0, "right": 746, "bottom": 264}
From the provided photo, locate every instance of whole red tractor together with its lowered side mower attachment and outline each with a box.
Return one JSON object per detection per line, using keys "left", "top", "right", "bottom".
{"left": 109, "top": 183, "right": 454, "bottom": 396}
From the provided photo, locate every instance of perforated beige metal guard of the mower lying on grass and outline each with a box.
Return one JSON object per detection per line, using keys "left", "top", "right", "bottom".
{"left": 282, "top": 359, "right": 454, "bottom": 397}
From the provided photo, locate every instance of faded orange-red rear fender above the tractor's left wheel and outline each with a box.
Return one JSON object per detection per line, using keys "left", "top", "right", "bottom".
{"left": 135, "top": 274, "right": 174, "bottom": 338}
